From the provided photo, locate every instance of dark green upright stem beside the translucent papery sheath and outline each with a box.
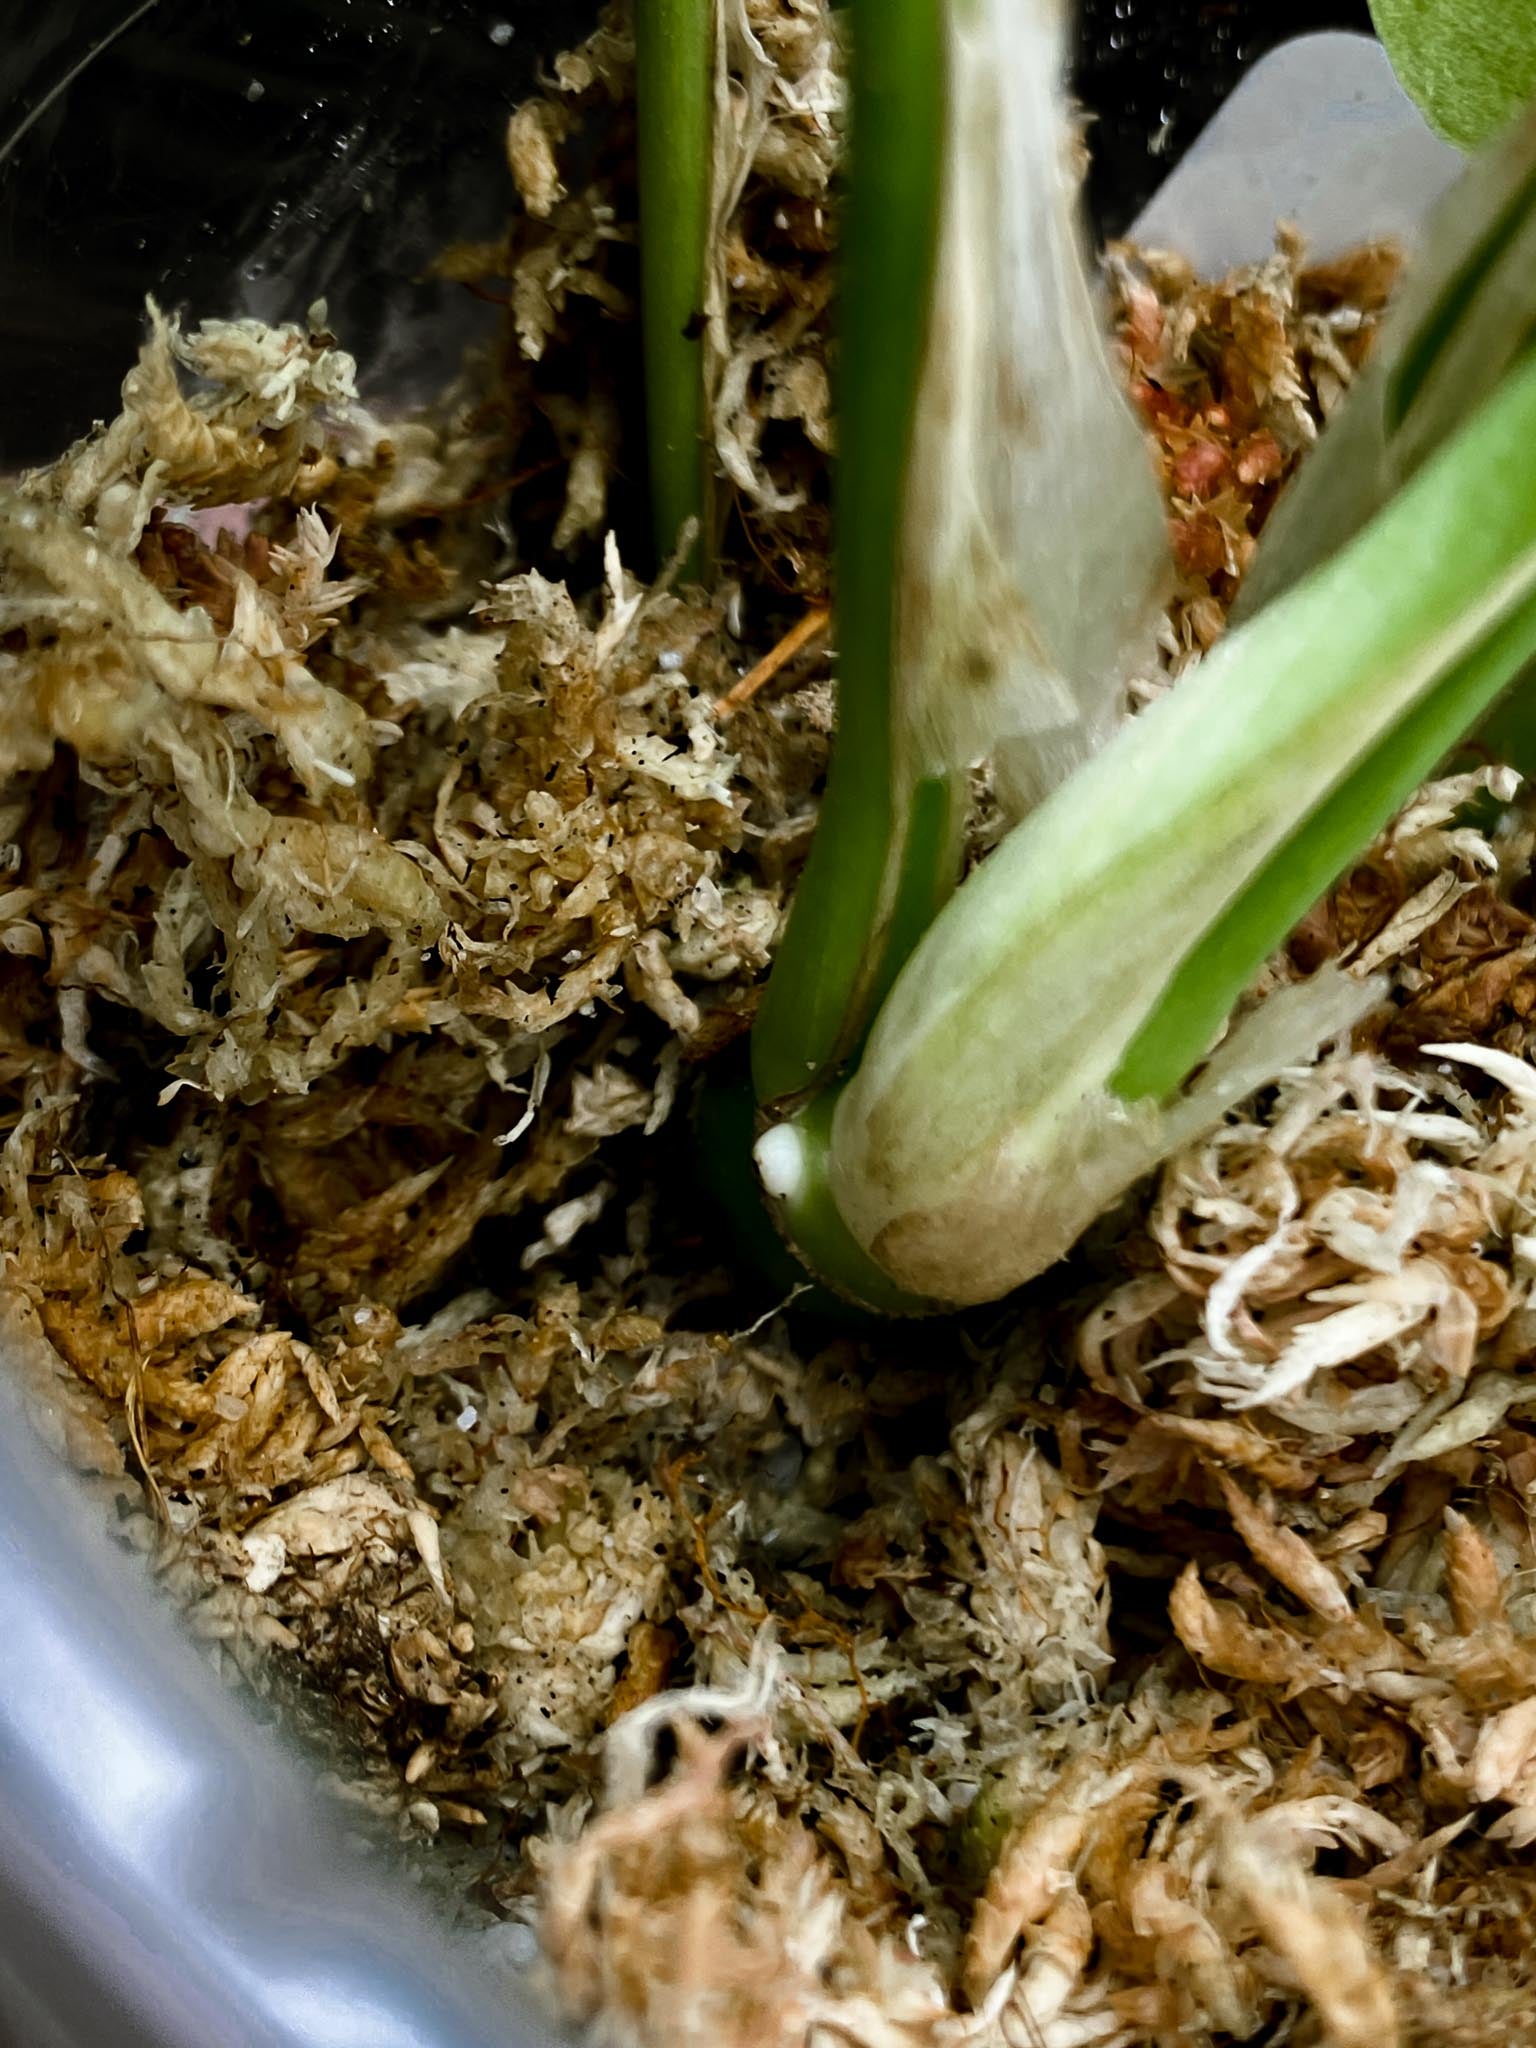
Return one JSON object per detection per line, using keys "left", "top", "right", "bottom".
{"left": 752, "top": 0, "right": 956, "bottom": 1102}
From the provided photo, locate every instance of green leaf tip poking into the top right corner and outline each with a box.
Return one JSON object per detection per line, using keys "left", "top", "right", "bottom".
{"left": 1370, "top": 0, "right": 1536, "bottom": 150}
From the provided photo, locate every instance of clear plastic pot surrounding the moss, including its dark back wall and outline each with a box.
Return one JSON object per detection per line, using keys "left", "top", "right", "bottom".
{"left": 0, "top": 16, "right": 1454, "bottom": 2048}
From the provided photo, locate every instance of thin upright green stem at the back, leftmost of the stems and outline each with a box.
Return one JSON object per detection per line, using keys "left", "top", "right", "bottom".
{"left": 635, "top": 0, "right": 715, "bottom": 578}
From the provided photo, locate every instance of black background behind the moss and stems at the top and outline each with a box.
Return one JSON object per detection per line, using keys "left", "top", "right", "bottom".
{"left": 0, "top": 0, "right": 1368, "bottom": 471}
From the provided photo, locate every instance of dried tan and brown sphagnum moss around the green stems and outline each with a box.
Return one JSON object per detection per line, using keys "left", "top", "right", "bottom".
{"left": 0, "top": 0, "right": 1536, "bottom": 2048}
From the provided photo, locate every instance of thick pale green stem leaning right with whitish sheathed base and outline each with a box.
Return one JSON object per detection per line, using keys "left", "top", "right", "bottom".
{"left": 811, "top": 348, "right": 1536, "bottom": 1300}
